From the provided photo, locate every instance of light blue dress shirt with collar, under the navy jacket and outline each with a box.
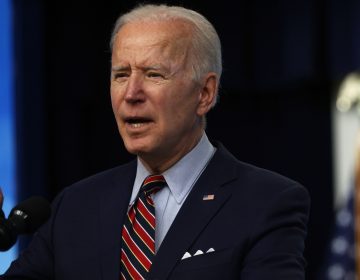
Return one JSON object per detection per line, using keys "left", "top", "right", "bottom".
{"left": 129, "top": 133, "right": 216, "bottom": 251}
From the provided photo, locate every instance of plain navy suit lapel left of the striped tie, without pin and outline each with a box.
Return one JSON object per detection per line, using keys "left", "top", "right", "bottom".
{"left": 99, "top": 161, "right": 136, "bottom": 280}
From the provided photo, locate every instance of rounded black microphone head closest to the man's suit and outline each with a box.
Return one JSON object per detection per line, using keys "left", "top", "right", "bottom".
{"left": 9, "top": 196, "right": 51, "bottom": 234}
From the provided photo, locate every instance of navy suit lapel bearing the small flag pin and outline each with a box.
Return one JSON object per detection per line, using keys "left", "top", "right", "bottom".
{"left": 149, "top": 147, "right": 235, "bottom": 279}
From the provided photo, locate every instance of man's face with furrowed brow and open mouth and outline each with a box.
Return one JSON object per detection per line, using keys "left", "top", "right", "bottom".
{"left": 111, "top": 19, "right": 211, "bottom": 171}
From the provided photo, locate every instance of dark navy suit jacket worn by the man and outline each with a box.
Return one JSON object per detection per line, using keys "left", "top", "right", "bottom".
{"left": 2, "top": 145, "right": 310, "bottom": 280}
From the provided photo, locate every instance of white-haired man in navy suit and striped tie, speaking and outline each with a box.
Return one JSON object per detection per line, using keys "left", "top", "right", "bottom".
{"left": 3, "top": 5, "right": 309, "bottom": 280}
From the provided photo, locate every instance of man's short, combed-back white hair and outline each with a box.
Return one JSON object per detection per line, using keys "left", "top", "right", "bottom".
{"left": 110, "top": 4, "right": 222, "bottom": 97}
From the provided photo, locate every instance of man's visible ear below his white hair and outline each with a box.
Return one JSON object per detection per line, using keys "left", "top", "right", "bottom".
{"left": 197, "top": 72, "right": 218, "bottom": 117}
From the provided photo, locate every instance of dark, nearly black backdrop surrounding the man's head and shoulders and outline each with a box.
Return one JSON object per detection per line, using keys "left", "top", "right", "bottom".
{"left": 13, "top": 0, "right": 360, "bottom": 279}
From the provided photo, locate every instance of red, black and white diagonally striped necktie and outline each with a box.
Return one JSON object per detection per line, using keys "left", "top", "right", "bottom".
{"left": 121, "top": 175, "right": 166, "bottom": 280}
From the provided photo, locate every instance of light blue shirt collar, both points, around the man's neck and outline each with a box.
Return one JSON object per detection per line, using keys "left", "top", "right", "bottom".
{"left": 130, "top": 133, "right": 215, "bottom": 205}
